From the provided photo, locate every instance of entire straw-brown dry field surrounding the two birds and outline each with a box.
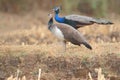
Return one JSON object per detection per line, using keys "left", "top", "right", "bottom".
{"left": 0, "top": 11, "right": 120, "bottom": 80}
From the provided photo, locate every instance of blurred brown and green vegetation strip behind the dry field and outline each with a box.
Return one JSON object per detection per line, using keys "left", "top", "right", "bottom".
{"left": 0, "top": 0, "right": 120, "bottom": 16}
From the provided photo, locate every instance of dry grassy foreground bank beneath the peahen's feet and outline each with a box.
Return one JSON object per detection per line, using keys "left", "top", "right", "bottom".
{"left": 0, "top": 43, "right": 120, "bottom": 80}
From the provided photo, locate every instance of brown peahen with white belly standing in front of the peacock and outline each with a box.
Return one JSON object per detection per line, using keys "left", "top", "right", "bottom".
{"left": 48, "top": 14, "right": 92, "bottom": 51}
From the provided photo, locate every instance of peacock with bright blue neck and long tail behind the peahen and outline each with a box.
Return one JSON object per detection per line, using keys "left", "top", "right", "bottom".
{"left": 53, "top": 6, "right": 113, "bottom": 29}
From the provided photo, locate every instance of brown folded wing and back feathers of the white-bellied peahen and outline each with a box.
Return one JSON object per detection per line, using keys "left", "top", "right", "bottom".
{"left": 56, "top": 24, "right": 87, "bottom": 45}
